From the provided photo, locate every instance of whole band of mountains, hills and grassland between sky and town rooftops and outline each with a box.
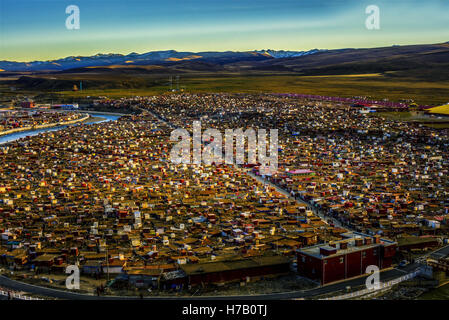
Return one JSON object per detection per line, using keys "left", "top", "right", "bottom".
{"left": 0, "top": 43, "right": 449, "bottom": 105}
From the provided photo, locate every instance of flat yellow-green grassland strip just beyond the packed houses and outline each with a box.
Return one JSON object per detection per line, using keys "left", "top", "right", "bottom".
{"left": 0, "top": 74, "right": 449, "bottom": 105}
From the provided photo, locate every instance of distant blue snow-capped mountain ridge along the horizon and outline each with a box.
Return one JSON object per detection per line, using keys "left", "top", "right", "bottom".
{"left": 0, "top": 49, "right": 325, "bottom": 72}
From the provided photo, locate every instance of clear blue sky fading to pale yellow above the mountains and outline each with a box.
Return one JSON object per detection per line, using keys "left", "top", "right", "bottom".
{"left": 0, "top": 0, "right": 449, "bottom": 61}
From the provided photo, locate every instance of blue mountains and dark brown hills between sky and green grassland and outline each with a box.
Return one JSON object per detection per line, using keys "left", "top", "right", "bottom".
{"left": 0, "top": 43, "right": 449, "bottom": 95}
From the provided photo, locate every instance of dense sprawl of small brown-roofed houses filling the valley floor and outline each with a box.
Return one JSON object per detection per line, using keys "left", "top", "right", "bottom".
{"left": 0, "top": 94, "right": 449, "bottom": 287}
